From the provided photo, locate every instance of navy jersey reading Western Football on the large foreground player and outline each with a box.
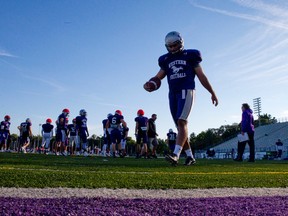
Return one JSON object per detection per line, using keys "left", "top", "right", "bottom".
{"left": 158, "top": 49, "right": 202, "bottom": 92}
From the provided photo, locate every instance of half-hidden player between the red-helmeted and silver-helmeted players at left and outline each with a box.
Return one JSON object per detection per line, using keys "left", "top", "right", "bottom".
{"left": 67, "top": 118, "right": 80, "bottom": 155}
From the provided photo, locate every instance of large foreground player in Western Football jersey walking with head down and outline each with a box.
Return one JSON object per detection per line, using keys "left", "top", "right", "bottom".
{"left": 144, "top": 31, "right": 218, "bottom": 165}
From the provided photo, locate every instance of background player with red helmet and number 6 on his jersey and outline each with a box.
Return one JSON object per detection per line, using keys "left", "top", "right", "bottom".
{"left": 106, "top": 110, "right": 127, "bottom": 157}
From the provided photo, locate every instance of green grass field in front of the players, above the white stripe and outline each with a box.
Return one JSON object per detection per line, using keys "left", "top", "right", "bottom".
{"left": 0, "top": 153, "right": 288, "bottom": 189}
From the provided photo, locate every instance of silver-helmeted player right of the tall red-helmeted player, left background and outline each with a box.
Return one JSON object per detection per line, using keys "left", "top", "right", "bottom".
{"left": 76, "top": 109, "right": 89, "bottom": 156}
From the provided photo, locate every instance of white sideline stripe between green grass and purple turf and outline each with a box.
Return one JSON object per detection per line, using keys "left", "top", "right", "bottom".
{"left": 0, "top": 187, "right": 288, "bottom": 199}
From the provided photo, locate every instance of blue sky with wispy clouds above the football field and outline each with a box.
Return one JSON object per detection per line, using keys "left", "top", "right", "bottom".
{"left": 0, "top": 0, "right": 288, "bottom": 138}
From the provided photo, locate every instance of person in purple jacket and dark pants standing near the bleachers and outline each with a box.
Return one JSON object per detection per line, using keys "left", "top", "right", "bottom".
{"left": 235, "top": 103, "right": 255, "bottom": 162}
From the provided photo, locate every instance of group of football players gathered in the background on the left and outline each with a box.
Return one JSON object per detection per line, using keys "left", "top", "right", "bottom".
{"left": 0, "top": 108, "right": 176, "bottom": 158}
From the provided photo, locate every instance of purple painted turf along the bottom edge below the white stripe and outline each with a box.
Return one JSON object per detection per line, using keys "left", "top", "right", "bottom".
{"left": 0, "top": 196, "right": 288, "bottom": 216}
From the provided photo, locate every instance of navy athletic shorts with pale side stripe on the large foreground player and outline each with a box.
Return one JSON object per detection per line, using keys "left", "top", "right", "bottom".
{"left": 169, "top": 89, "right": 195, "bottom": 126}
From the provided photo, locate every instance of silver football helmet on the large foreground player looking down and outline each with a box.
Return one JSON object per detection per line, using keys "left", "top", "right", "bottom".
{"left": 165, "top": 31, "right": 184, "bottom": 54}
